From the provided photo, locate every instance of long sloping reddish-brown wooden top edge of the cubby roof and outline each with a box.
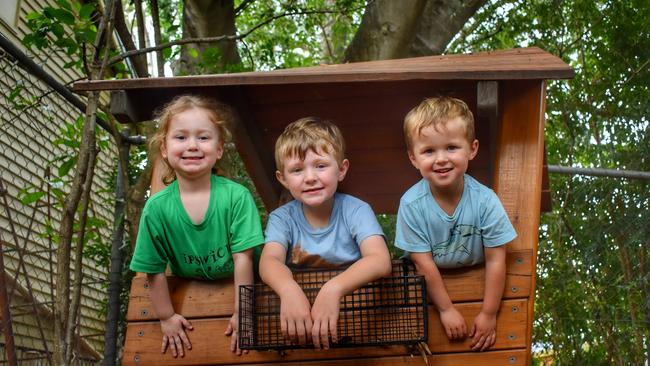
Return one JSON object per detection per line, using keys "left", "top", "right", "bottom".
{"left": 73, "top": 47, "right": 574, "bottom": 91}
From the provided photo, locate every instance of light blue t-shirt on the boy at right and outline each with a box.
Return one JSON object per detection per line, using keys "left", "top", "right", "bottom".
{"left": 395, "top": 174, "right": 517, "bottom": 268}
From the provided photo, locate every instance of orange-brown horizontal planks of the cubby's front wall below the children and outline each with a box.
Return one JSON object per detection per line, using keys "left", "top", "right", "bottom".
{"left": 122, "top": 251, "right": 532, "bottom": 365}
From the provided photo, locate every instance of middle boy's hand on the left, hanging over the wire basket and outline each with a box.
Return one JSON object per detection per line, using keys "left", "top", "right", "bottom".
{"left": 280, "top": 288, "right": 312, "bottom": 346}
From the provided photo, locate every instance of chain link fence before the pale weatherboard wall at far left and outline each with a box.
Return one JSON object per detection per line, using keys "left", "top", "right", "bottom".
{"left": 0, "top": 46, "right": 116, "bottom": 365}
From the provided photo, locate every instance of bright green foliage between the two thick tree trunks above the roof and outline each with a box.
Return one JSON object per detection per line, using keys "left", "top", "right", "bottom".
{"left": 237, "top": 0, "right": 365, "bottom": 70}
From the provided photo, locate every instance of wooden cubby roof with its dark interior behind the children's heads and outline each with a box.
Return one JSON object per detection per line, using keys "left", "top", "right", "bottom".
{"left": 74, "top": 48, "right": 573, "bottom": 213}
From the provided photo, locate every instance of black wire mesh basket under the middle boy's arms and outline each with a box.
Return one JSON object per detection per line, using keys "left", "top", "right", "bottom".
{"left": 239, "top": 262, "right": 428, "bottom": 350}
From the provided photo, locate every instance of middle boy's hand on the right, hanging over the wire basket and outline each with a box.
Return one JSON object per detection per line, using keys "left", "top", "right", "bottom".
{"left": 311, "top": 282, "right": 341, "bottom": 349}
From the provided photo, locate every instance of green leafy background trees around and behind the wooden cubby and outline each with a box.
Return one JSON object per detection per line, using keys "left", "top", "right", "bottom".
{"left": 16, "top": 0, "right": 650, "bottom": 365}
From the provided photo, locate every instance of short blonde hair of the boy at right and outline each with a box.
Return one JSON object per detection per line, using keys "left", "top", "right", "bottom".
{"left": 404, "top": 97, "right": 475, "bottom": 150}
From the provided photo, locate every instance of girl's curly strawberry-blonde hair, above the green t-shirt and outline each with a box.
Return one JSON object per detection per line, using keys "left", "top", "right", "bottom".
{"left": 149, "top": 95, "right": 233, "bottom": 184}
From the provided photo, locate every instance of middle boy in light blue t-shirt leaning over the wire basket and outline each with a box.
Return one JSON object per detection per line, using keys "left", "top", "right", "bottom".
{"left": 260, "top": 117, "right": 391, "bottom": 349}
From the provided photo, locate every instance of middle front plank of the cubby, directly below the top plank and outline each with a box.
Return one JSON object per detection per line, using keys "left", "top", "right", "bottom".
{"left": 122, "top": 300, "right": 527, "bottom": 365}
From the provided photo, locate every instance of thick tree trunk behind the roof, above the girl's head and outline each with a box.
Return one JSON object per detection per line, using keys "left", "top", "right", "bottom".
{"left": 174, "top": 0, "right": 241, "bottom": 75}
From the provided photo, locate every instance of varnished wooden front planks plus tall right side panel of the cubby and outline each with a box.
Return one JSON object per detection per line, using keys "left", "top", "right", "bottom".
{"left": 123, "top": 80, "right": 545, "bottom": 365}
